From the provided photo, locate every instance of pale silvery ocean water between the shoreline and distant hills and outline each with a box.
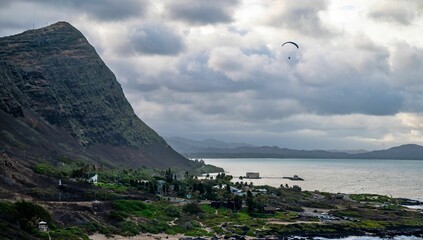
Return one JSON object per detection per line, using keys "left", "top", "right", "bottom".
{"left": 203, "top": 158, "right": 423, "bottom": 201}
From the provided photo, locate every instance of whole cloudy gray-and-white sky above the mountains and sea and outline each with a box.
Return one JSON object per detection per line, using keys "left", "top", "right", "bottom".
{"left": 0, "top": 0, "right": 423, "bottom": 150}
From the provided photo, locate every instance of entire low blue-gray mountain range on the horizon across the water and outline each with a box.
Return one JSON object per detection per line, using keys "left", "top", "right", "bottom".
{"left": 166, "top": 137, "right": 423, "bottom": 160}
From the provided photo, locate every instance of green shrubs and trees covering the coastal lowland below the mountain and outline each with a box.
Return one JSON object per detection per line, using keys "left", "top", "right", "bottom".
{"left": 0, "top": 155, "right": 423, "bottom": 239}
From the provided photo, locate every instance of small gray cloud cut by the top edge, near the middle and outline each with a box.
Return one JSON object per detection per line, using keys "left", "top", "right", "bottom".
{"left": 166, "top": 0, "right": 239, "bottom": 25}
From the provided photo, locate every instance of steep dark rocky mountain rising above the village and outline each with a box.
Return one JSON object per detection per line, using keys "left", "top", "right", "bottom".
{"left": 0, "top": 22, "right": 192, "bottom": 167}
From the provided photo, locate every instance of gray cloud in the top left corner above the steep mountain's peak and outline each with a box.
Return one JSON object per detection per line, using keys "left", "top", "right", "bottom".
{"left": 0, "top": 0, "right": 148, "bottom": 35}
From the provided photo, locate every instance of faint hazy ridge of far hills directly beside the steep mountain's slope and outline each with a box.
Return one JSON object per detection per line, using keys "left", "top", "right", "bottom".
{"left": 165, "top": 137, "right": 253, "bottom": 153}
